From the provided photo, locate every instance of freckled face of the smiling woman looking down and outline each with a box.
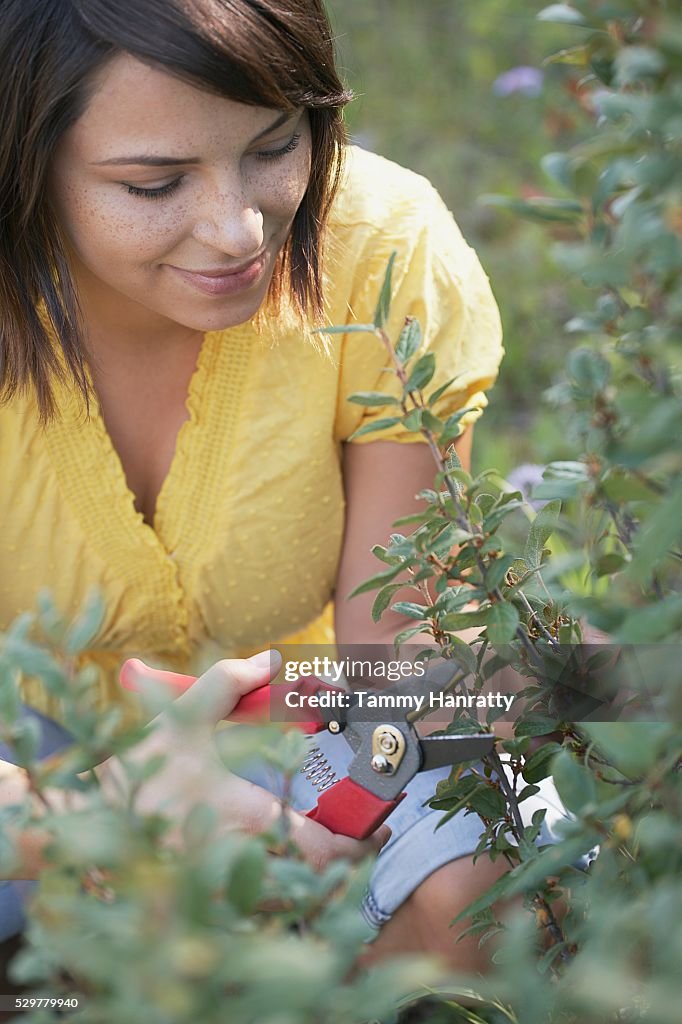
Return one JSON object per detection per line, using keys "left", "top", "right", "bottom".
{"left": 51, "top": 55, "right": 310, "bottom": 332}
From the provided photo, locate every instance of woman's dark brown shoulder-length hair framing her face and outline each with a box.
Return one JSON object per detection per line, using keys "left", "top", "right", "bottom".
{"left": 0, "top": 0, "right": 350, "bottom": 420}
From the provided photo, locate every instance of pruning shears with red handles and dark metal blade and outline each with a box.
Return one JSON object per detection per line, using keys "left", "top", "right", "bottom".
{"left": 120, "top": 658, "right": 495, "bottom": 839}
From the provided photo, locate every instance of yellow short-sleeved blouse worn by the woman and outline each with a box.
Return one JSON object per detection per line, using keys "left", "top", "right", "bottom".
{"left": 0, "top": 147, "right": 502, "bottom": 714}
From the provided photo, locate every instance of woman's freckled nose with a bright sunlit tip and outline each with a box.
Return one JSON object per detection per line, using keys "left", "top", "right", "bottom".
{"left": 193, "top": 176, "right": 264, "bottom": 259}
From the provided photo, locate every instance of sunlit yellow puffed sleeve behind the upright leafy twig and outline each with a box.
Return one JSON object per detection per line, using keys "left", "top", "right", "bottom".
{"left": 336, "top": 169, "right": 504, "bottom": 443}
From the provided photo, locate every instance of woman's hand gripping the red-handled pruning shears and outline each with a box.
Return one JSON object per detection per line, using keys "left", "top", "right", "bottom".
{"left": 97, "top": 651, "right": 382, "bottom": 868}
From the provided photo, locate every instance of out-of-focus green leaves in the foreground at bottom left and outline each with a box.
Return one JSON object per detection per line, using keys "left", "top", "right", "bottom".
{"left": 0, "top": 595, "right": 436, "bottom": 1024}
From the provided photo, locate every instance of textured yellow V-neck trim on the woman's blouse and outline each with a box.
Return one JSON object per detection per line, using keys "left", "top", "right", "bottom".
{"left": 45, "top": 324, "right": 256, "bottom": 653}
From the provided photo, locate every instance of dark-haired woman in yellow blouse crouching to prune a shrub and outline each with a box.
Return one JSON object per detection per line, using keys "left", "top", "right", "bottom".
{"left": 0, "top": 0, "right": 501, "bottom": 967}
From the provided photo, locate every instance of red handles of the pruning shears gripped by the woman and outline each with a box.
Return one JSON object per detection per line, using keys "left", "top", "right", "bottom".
{"left": 119, "top": 657, "right": 404, "bottom": 839}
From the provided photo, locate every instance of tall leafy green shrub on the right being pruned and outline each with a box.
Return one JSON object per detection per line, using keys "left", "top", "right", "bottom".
{"left": 331, "top": 0, "right": 682, "bottom": 1024}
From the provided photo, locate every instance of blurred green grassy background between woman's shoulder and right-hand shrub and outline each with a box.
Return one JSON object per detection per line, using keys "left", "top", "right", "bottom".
{"left": 328, "top": 0, "right": 589, "bottom": 473}
